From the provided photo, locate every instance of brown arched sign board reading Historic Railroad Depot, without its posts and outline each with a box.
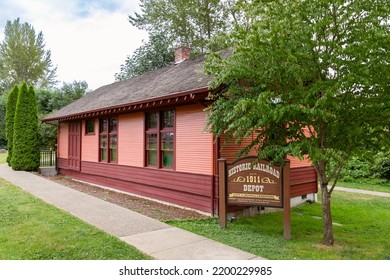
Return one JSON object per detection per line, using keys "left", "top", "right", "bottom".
{"left": 226, "top": 157, "right": 283, "bottom": 208}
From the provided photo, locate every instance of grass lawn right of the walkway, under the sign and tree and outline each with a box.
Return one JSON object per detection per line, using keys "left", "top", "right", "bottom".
{"left": 168, "top": 191, "right": 390, "bottom": 260}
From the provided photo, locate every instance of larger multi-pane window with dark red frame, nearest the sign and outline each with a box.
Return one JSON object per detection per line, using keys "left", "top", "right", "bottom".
{"left": 146, "top": 110, "right": 175, "bottom": 168}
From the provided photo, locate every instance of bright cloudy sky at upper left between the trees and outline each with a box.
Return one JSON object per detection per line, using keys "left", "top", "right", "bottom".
{"left": 0, "top": 0, "right": 147, "bottom": 89}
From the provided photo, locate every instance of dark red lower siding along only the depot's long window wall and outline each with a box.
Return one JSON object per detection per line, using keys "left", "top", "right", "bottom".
{"left": 60, "top": 159, "right": 213, "bottom": 213}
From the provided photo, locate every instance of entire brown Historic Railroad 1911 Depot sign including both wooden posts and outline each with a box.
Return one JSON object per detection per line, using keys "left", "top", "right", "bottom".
{"left": 218, "top": 157, "right": 291, "bottom": 239}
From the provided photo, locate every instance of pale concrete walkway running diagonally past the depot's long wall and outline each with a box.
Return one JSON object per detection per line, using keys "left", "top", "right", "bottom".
{"left": 0, "top": 164, "right": 262, "bottom": 260}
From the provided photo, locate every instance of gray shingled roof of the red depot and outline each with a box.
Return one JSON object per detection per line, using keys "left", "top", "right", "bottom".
{"left": 43, "top": 53, "right": 211, "bottom": 121}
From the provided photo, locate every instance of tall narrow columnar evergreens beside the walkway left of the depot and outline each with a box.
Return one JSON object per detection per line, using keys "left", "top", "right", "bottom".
{"left": 11, "top": 82, "right": 40, "bottom": 171}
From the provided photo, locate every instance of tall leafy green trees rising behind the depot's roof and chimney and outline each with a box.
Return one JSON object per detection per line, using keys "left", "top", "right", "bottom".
{"left": 115, "top": 0, "right": 236, "bottom": 81}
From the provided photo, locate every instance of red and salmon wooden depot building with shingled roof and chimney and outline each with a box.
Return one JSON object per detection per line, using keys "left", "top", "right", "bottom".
{"left": 43, "top": 47, "right": 317, "bottom": 214}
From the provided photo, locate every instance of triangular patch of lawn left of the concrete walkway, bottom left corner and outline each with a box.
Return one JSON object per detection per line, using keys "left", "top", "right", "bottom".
{"left": 0, "top": 179, "right": 150, "bottom": 260}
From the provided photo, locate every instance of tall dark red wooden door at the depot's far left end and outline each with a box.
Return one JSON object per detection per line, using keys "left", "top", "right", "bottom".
{"left": 68, "top": 122, "right": 81, "bottom": 171}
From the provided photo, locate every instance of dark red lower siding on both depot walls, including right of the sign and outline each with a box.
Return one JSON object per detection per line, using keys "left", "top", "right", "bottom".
{"left": 58, "top": 158, "right": 318, "bottom": 213}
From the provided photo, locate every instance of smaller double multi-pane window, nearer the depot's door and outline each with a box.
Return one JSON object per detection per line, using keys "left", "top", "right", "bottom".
{"left": 99, "top": 117, "right": 118, "bottom": 162}
